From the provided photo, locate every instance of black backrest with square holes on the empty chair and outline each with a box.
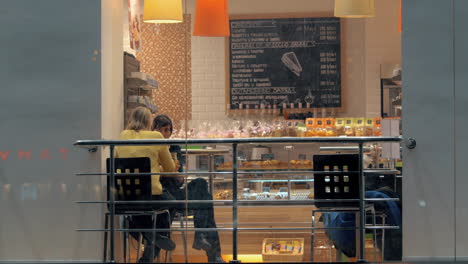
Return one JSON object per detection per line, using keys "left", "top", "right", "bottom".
{"left": 314, "top": 154, "right": 359, "bottom": 208}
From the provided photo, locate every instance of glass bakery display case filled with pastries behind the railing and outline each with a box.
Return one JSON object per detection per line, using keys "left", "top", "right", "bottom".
{"left": 180, "top": 144, "right": 399, "bottom": 201}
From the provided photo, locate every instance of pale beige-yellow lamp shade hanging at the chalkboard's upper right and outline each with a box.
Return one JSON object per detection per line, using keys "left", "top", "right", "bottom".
{"left": 335, "top": 0, "right": 375, "bottom": 18}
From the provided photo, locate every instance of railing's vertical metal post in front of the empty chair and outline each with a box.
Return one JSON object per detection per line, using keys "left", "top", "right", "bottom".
{"left": 358, "top": 143, "right": 367, "bottom": 262}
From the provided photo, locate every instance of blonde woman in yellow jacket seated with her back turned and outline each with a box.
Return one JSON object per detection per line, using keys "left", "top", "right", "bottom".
{"left": 115, "top": 107, "right": 177, "bottom": 263}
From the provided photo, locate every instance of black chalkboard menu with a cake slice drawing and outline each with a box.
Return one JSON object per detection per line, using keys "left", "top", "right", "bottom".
{"left": 229, "top": 17, "right": 341, "bottom": 109}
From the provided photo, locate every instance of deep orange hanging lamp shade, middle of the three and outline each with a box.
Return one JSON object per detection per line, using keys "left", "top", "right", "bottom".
{"left": 193, "top": 0, "right": 229, "bottom": 37}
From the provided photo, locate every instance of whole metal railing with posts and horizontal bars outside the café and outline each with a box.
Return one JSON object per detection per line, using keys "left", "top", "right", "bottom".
{"left": 74, "top": 137, "right": 403, "bottom": 262}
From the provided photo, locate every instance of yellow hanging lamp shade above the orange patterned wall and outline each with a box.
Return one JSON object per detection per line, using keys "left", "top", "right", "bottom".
{"left": 143, "top": 0, "right": 184, "bottom": 23}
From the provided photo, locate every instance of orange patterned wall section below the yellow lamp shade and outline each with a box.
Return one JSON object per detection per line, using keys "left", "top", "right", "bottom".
{"left": 137, "top": 15, "right": 192, "bottom": 128}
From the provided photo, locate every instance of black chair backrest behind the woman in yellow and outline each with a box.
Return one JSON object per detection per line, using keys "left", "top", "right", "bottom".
{"left": 106, "top": 157, "right": 151, "bottom": 211}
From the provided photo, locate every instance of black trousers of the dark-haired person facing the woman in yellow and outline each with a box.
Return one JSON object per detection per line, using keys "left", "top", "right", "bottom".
{"left": 130, "top": 178, "right": 221, "bottom": 253}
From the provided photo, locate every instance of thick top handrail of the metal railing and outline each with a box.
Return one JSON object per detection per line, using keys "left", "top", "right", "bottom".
{"left": 73, "top": 137, "right": 403, "bottom": 147}
